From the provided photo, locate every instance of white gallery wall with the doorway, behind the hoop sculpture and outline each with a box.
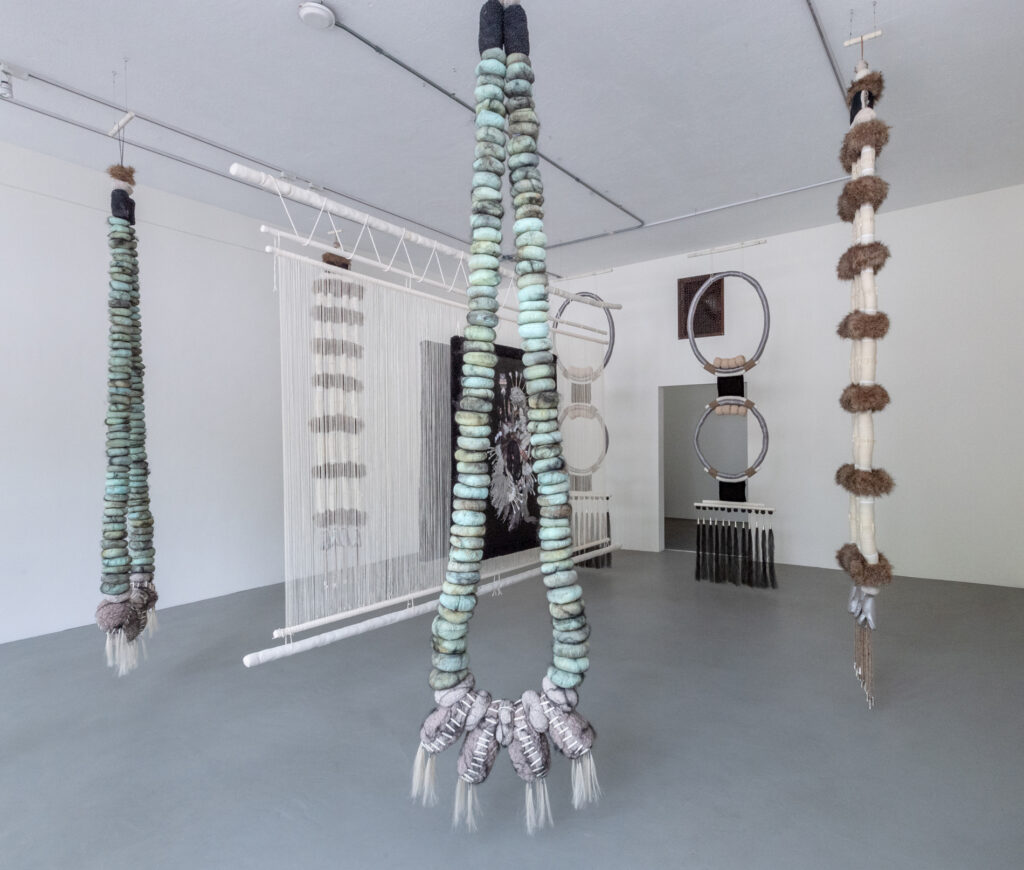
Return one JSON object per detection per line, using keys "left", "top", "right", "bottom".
{"left": 589, "top": 182, "right": 1024, "bottom": 586}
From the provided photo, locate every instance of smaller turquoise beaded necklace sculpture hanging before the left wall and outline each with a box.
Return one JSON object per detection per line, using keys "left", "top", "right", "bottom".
{"left": 96, "top": 164, "right": 157, "bottom": 677}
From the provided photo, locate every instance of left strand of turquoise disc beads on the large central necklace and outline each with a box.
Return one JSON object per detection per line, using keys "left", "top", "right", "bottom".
{"left": 429, "top": 48, "right": 506, "bottom": 691}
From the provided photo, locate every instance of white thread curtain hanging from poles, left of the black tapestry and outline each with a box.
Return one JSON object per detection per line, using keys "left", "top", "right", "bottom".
{"left": 274, "top": 255, "right": 585, "bottom": 632}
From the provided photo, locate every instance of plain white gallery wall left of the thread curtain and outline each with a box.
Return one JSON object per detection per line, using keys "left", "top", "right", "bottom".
{"left": 0, "top": 143, "right": 283, "bottom": 642}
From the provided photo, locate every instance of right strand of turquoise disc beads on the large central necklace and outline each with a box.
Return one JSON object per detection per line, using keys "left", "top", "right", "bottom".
{"left": 505, "top": 52, "right": 590, "bottom": 689}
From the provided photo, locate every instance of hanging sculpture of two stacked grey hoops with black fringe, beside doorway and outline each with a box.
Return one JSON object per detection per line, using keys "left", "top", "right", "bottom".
{"left": 686, "top": 271, "right": 778, "bottom": 589}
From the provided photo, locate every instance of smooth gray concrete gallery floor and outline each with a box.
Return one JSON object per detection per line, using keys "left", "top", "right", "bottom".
{"left": 0, "top": 553, "right": 1024, "bottom": 870}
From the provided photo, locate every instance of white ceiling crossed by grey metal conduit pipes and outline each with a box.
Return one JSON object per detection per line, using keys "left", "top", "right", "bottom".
{"left": 0, "top": 0, "right": 1024, "bottom": 274}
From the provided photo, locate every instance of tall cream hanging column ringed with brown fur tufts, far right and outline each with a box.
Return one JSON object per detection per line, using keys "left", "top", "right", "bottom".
{"left": 836, "top": 59, "right": 893, "bottom": 707}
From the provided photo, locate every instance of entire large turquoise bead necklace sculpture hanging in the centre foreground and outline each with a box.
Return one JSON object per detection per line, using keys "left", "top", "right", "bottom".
{"left": 412, "top": 0, "right": 600, "bottom": 833}
